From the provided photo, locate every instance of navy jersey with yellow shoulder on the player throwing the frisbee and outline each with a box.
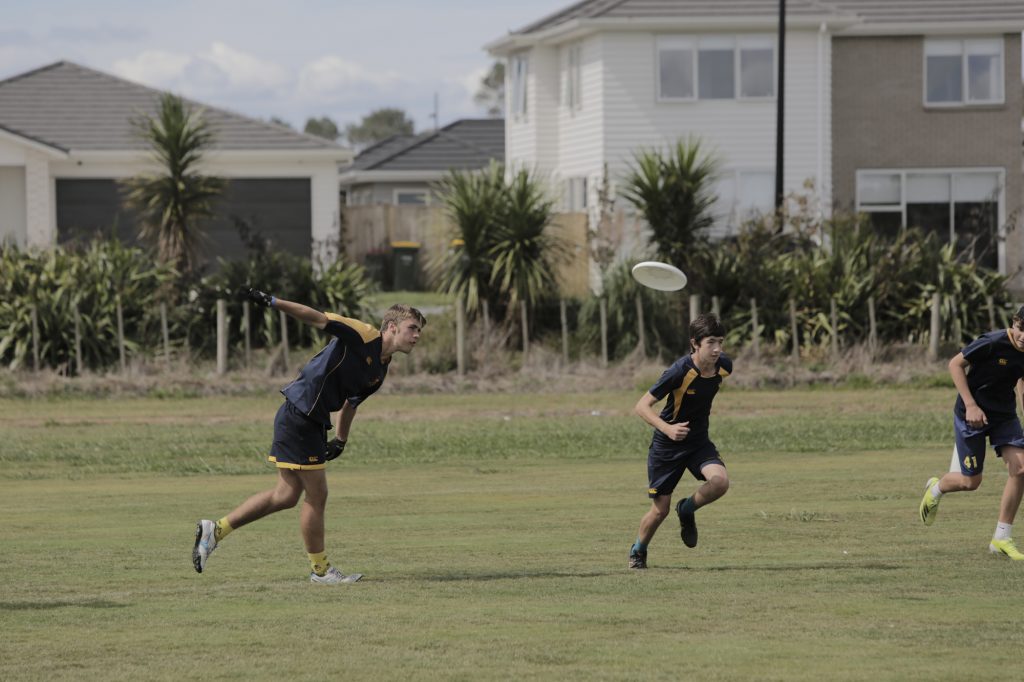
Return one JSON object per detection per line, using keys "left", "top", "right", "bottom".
{"left": 281, "top": 312, "right": 387, "bottom": 428}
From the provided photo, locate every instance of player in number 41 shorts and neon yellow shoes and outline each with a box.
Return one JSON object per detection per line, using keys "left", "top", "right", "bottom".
{"left": 919, "top": 305, "right": 1024, "bottom": 561}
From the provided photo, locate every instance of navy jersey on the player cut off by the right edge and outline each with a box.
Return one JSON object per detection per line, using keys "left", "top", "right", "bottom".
{"left": 953, "top": 329, "right": 1024, "bottom": 422}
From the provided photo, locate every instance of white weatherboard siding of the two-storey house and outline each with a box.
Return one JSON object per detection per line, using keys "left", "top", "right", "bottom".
{"left": 506, "top": 31, "right": 831, "bottom": 215}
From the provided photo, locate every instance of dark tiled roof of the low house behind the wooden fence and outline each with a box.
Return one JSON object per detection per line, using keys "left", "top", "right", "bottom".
{"left": 349, "top": 119, "right": 505, "bottom": 171}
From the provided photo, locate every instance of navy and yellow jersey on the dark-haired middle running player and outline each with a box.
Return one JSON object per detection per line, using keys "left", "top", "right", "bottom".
{"left": 649, "top": 353, "right": 732, "bottom": 452}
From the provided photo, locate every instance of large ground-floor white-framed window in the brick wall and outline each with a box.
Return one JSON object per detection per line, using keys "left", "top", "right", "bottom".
{"left": 856, "top": 168, "right": 1006, "bottom": 271}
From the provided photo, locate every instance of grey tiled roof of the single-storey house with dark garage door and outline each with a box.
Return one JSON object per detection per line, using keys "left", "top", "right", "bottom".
{"left": 0, "top": 61, "right": 341, "bottom": 151}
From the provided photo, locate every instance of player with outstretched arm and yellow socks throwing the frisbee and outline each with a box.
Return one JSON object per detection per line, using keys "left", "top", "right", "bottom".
{"left": 193, "top": 289, "right": 427, "bottom": 585}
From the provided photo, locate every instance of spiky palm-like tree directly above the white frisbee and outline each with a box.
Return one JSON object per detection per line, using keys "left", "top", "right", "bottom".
{"left": 624, "top": 137, "right": 718, "bottom": 272}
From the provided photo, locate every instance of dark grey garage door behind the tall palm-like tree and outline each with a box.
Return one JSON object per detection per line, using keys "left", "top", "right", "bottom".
{"left": 56, "top": 178, "right": 312, "bottom": 261}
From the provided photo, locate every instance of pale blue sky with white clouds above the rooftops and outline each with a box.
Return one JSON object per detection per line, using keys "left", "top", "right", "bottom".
{"left": 0, "top": 0, "right": 572, "bottom": 129}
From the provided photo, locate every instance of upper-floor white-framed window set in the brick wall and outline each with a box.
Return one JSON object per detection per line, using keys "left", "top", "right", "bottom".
{"left": 925, "top": 38, "right": 1004, "bottom": 106}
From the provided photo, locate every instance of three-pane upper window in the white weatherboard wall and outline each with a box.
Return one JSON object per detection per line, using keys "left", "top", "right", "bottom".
{"left": 656, "top": 36, "right": 775, "bottom": 101}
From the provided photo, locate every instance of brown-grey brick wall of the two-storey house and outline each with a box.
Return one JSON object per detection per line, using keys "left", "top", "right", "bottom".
{"left": 831, "top": 34, "right": 1024, "bottom": 280}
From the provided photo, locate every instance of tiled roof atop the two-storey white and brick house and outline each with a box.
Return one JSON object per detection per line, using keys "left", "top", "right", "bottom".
{"left": 513, "top": 0, "right": 1024, "bottom": 35}
